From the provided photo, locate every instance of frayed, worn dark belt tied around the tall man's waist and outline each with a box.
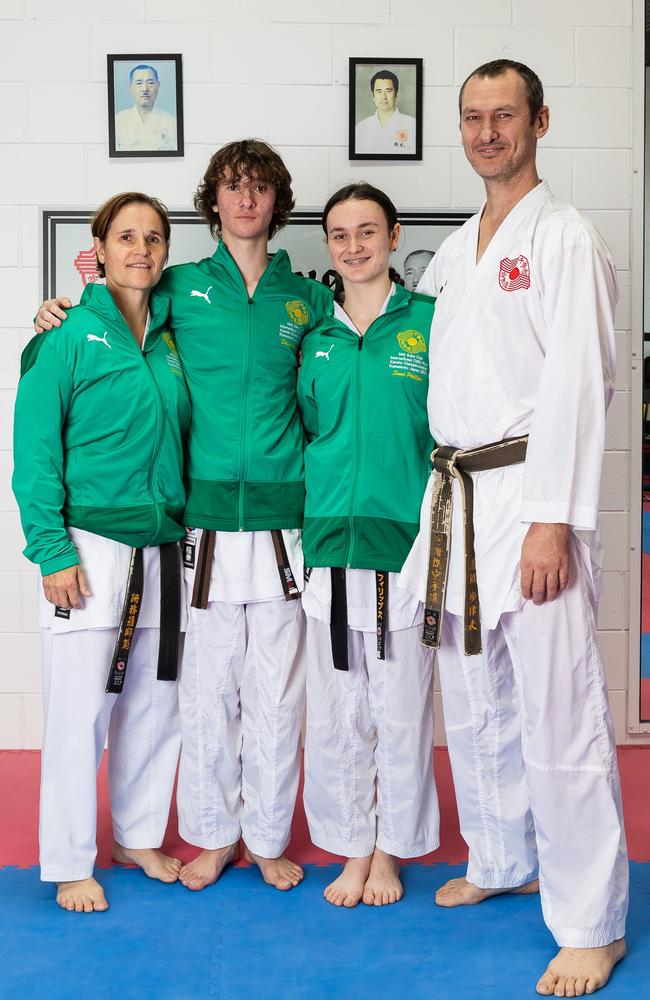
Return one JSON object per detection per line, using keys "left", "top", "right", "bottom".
{"left": 422, "top": 435, "right": 528, "bottom": 656}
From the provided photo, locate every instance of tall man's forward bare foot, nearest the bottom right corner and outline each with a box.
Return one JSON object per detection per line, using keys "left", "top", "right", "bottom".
{"left": 536, "top": 938, "right": 625, "bottom": 997}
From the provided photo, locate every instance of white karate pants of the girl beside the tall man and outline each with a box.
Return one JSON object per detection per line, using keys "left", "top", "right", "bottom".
{"left": 304, "top": 617, "right": 439, "bottom": 858}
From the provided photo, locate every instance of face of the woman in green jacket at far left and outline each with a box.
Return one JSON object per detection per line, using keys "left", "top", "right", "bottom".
{"left": 94, "top": 202, "right": 168, "bottom": 291}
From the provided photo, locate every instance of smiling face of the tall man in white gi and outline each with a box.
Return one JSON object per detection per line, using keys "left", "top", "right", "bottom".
{"left": 460, "top": 69, "right": 549, "bottom": 182}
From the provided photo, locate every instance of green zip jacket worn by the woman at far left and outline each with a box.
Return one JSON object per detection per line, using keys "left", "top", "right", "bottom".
{"left": 12, "top": 285, "right": 190, "bottom": 576}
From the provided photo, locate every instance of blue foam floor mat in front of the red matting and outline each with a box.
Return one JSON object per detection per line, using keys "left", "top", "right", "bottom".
{"left": 0, "top": 863, "right": 650, "bottom": 1000}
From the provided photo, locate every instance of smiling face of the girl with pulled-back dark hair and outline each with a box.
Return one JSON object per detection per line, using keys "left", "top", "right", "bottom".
{"left": 326, "top": 198, "right": 400, "bottom": 284}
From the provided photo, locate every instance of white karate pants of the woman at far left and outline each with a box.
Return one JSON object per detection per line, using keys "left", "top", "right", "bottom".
{"left": 39, "top": 628, "right": 180, "bottom": 882}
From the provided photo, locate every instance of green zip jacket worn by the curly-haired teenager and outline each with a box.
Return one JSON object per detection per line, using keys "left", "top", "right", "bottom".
{"left": 156, "top": 243, "right": 332, "bottom": 531}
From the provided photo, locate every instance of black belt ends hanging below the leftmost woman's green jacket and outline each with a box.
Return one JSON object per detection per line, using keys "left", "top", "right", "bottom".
{"left": 106, "top": 542, "right": 181, "bottom": 694}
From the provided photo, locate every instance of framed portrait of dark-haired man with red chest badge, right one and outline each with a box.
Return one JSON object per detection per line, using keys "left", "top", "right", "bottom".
{"left": 349, "top": 58, "right": 422, "bottom": 160}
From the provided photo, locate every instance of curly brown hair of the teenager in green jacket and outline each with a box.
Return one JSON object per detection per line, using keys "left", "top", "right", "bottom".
{"left": 194, "top": 139, "right": 295, "bottom": 239}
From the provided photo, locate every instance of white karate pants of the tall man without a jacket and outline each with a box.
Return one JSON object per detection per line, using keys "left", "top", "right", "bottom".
{"left": 438, "top": 539, "right": 628, "bottom": 948}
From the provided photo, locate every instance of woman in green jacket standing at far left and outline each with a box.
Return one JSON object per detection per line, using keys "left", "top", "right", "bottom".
{"left": 13, "top": 192, "right": 190, "bottom": 913}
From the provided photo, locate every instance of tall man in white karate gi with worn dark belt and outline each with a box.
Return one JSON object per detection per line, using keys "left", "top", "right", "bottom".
{"left": 403, "top": 60, "right": 628, "bottom": 997}
